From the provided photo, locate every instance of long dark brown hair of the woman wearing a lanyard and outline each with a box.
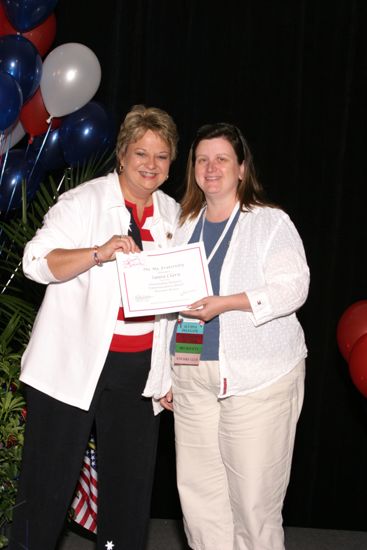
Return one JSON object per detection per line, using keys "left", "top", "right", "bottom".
{"left": 181, "top": 122, "right": 276, "bottom": 223}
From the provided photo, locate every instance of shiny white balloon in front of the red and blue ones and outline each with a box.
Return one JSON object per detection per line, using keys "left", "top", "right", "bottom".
{"left": 40, "top": 42, "right": 101, "bottom": 117}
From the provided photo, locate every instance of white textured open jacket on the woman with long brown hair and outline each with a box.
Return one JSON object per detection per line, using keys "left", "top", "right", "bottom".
{"left": 146, "top": 207, "right": 309, "bottom": 408}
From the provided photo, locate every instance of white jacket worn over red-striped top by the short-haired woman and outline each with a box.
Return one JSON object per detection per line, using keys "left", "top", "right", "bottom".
{"left": 20, "top": 172, "right": 179, "bottom": 410}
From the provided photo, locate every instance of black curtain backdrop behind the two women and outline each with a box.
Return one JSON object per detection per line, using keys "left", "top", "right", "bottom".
{"left": 54, "top": 0, "right": 367, "bottom": 530}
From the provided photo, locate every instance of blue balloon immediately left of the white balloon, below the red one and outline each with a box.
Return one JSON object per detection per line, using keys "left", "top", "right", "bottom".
{"left": 0, "top": 34, "right": 42, "bottom": 102}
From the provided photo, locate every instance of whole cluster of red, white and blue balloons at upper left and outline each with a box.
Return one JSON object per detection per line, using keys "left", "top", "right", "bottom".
{"left": 0, "top": 0, "right": 114, "bottom": 213}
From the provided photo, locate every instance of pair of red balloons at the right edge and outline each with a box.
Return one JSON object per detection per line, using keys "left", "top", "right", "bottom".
{"left": 337, "top": 300, "right": 367, "bottom": 397}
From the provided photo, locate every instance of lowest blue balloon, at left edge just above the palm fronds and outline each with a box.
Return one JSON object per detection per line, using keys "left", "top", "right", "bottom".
{"left": 0, "top": 149, "right": 44, "bottom": 214}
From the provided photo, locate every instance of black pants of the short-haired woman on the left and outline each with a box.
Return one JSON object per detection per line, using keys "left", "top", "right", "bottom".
{"left": 9, "top": 351, "right": 159, "bottom": 550}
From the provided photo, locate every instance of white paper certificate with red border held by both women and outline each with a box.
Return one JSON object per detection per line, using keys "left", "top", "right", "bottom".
{"left": 116, "top": 242, "right": 213, "bottom": 317}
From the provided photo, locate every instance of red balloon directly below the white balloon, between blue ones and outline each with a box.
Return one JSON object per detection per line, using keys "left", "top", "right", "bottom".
{"left": 19, "top": 88, "right": 61, "bottom": 143}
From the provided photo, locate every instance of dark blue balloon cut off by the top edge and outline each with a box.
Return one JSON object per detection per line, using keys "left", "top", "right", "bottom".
{"left": 3, "top": 0, "right": 57, "bottom": 32}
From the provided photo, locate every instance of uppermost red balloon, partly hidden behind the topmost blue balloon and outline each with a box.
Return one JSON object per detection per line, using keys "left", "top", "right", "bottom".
{"left": 0, "top": 3, "right": 56, "bottom": 57}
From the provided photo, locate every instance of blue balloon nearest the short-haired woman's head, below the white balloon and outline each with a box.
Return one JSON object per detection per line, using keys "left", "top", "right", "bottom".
{"left": 59, "top": 101, "right": 115, "bottom": 166}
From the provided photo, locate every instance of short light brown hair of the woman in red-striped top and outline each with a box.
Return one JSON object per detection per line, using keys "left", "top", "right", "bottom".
{"left": 116, "top": 105, "right": 178, "bottom": 169}
